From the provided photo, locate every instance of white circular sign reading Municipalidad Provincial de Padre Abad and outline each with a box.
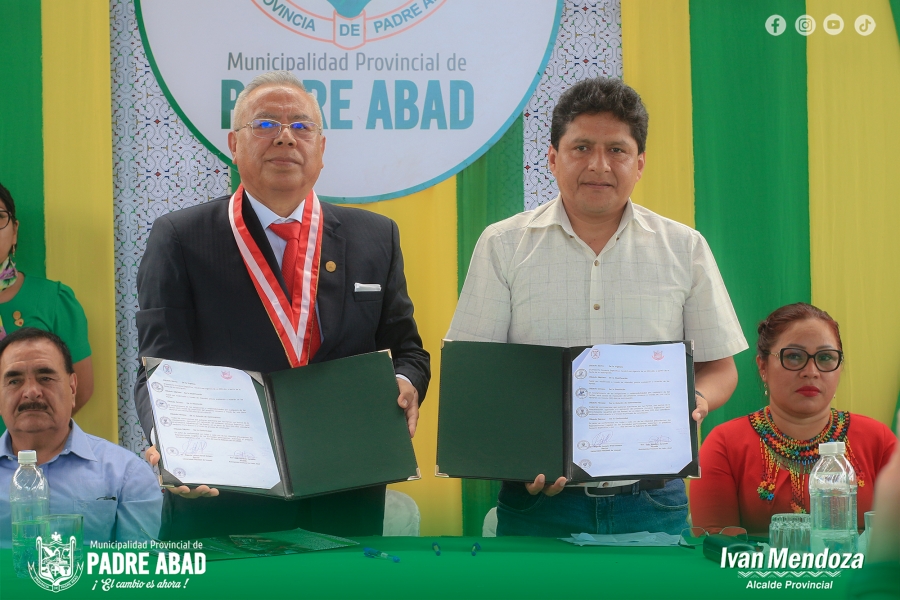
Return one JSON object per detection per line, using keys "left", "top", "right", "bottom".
{"left": 135, "top": 0, "right": 563, "bottom": 202}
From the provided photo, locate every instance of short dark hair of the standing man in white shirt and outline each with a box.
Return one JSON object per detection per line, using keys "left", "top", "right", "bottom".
{"left": 550, "top": 77, "right": 650, "bottom": 154}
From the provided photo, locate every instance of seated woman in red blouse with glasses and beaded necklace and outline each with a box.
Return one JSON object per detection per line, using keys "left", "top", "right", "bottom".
{"left": 690, "top": 302, "right": 897, "bottom": 536}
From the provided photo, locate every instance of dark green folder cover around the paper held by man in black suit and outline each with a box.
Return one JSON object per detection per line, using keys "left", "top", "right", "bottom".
{"left": 143, "top": 350, "right": 420, "bottom": 500}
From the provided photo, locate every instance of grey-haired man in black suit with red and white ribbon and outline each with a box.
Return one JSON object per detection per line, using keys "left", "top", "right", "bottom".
{"left": 135, "top": 71, "right": 430, "bottom": 539}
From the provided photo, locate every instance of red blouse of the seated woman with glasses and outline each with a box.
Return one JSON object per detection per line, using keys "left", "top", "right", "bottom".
{"left": 690, "top": 413, "right": 897, "bottom": 537}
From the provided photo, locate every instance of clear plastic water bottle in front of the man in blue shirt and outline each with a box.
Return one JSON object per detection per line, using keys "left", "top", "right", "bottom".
{"left": 9, "top": 450, "right": 50, "bottom": 577}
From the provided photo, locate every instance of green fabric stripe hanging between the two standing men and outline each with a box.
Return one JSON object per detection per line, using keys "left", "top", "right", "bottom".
{"left": 456, "top": 119, "right": 525, "bottom": 536}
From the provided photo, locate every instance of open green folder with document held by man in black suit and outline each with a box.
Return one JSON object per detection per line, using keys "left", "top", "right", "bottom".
{"left": 144, "top": 351, "right": 419, "bottom": 500}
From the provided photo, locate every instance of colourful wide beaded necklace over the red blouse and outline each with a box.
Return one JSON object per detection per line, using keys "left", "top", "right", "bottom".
{"left": 748, "top": 406, "right": 864, "bottom": 513}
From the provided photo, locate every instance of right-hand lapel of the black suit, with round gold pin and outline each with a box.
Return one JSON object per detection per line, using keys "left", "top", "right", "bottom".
{"left": 312, "top": 202, "right": 347, "bottom": 362}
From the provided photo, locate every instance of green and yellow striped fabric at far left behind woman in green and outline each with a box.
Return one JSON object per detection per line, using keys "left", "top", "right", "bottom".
{"left": 0, "top": 0, "right": 118, "bottom": 441}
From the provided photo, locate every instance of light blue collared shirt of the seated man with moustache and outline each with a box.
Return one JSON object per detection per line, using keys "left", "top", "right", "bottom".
{"left": 0, "top": 420, "right": 163, "bottom": 548}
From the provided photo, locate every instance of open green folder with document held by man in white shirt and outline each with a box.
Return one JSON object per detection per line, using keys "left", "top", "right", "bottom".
{"left": 437, "top": 340, "right": 700, "bottom": 482}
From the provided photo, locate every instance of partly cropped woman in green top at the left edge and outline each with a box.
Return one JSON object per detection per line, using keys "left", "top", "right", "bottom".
{"left": 0, "top": 184, "right": 94, "bottom": 418}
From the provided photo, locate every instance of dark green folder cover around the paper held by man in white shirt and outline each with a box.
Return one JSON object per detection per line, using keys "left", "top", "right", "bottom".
{"left": 435, "top": 340, "right": 700, "bottom": 483}
